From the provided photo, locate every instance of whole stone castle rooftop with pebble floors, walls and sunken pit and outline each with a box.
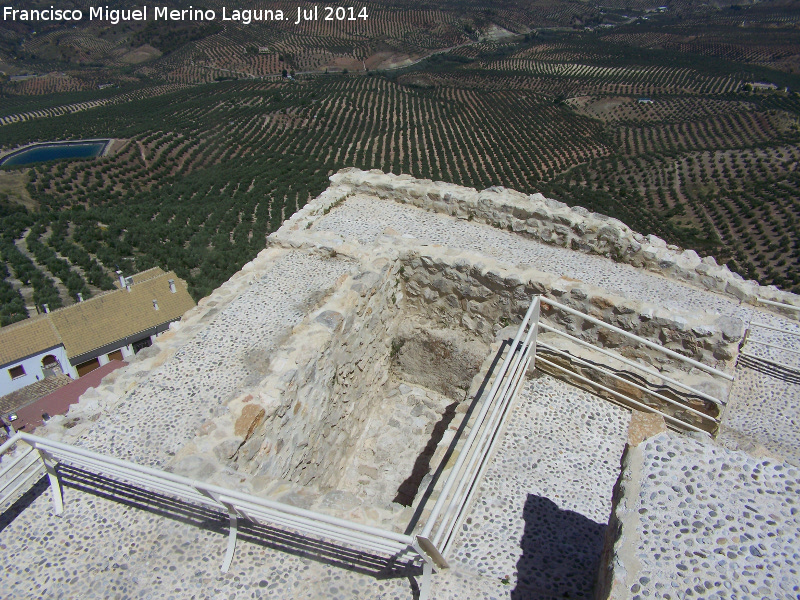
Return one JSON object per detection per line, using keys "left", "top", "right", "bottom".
{"left": 0, "top": 170, "right": 800, "bottom": 599}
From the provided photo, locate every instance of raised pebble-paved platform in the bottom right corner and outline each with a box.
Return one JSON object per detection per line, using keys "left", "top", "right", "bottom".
{"left": 627, "top": 432, "right": 800, "bottom": 600}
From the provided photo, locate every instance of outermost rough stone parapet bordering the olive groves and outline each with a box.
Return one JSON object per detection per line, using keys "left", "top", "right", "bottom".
{"left": 331, "top": 169, "right": 800, "bottom": 317}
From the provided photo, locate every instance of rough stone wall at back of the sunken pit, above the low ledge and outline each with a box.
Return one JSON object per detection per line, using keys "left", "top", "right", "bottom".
{"left": 402, "top": 249, "right": 744, "bottom": 370}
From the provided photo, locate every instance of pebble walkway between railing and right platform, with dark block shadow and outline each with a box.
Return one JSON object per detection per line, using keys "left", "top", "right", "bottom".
{"left": 443, "top": 375, "right": 630, "bottom": 600}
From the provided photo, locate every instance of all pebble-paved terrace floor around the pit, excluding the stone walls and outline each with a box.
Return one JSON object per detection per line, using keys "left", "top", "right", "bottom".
{"left": 0, "top": 171, "right": 800, "bottom": 600}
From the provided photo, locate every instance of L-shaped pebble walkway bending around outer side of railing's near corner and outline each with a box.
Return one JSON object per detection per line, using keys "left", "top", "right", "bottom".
{"left": 0, "top": 376, "right": 629, "bottom": 600}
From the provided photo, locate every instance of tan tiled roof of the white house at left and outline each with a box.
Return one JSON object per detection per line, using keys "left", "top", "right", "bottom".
{"left": 0, "top": 268, "right": 195, "bottom": 364}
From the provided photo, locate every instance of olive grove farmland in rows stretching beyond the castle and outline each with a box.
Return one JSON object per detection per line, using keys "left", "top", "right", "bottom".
{"left": 0, "top": 2, "right": 800, "bottom": 324}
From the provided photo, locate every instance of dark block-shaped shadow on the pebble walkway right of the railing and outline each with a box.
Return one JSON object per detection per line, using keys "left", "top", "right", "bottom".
{"left": 511, "top": 494, "right": 606, "bottom": 600}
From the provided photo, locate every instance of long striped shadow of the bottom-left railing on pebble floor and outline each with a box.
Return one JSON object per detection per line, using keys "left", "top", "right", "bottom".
{"left": 56, "top": 463, "right": 422, "bottom": 598}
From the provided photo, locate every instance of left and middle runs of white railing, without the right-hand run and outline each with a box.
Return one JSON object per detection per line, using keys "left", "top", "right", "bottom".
{"left": 0, "top": 297, "right": 539, "bottom": 600}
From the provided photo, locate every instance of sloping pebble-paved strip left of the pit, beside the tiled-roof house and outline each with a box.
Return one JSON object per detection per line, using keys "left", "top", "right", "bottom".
{"left": 76, "top": 251, "right": 351, "bottom": 466}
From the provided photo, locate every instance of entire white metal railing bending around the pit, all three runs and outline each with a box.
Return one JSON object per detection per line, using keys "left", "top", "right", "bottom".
{"left": 0, "top": 296, "right": 733, "bottom": 600}
